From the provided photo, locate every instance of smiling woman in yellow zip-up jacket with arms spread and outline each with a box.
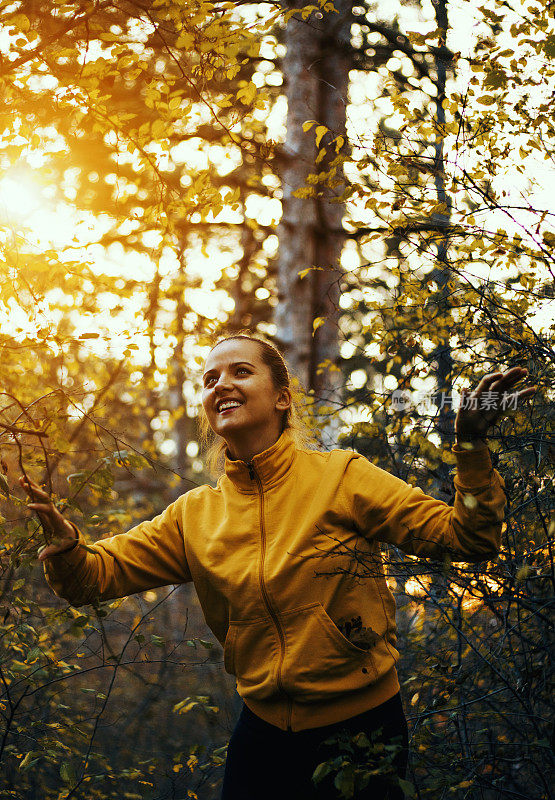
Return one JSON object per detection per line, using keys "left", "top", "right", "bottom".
{"left": 22, "top": 335, "right": 534, "bottom": 800}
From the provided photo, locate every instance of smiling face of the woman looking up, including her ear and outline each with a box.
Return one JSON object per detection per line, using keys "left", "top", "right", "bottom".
{"left": 202, "top": 339, "right": 291, "bottom": 452}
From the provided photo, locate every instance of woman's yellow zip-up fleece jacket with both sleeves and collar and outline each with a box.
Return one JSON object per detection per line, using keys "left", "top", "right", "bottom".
{"left": 45, "top": 432, "right": 505, "bottom": 731}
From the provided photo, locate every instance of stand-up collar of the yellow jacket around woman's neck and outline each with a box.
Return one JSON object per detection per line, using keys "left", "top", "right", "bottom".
{"left": 225, "top": 431, "right": 296, "bottom": 492}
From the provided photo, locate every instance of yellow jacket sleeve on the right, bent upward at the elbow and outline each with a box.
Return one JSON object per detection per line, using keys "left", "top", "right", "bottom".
{"left": 346, "top": 444, "right": 506, "bottom": 561}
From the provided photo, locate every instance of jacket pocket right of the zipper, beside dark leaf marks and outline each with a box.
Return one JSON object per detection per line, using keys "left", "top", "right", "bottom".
{"left": 281, "top": 603, "right": 382, "bottom": 702}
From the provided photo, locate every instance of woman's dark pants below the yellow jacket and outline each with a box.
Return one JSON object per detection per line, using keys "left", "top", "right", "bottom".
{"left": 222, "top": 694, "right": 408, "bottom": 800}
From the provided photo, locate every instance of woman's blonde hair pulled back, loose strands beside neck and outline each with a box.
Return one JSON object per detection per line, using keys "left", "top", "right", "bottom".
{"left": 198, "top": 332, "right": 315, "bottom": 475}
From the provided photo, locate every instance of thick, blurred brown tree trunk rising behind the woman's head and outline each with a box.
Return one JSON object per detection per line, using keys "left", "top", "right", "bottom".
{"left": 275, "top": 0, "right": 352, "bottom": 438}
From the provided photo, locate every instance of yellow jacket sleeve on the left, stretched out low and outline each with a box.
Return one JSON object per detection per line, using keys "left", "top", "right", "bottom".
{"left": 44, "top": 498, "right": 192, "bottom": 606}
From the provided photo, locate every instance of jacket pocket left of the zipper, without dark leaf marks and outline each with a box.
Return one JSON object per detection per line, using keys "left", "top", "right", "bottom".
{"left": 224, "top": 619, "right": 279, "bottom": 700}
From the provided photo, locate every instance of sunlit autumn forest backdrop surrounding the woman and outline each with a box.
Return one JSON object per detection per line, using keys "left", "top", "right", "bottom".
{"left": 0, "top": 0, "right": 555, "bottom": 800}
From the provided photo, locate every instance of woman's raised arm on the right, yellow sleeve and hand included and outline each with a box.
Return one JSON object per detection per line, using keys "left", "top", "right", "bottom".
{"left": 345, "top": 367, "right": 535, "bottom": 561}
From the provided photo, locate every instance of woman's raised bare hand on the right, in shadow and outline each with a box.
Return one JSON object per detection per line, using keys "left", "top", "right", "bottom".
{"left": 455, "top": 367, "right": 536, "bottom": 442}
